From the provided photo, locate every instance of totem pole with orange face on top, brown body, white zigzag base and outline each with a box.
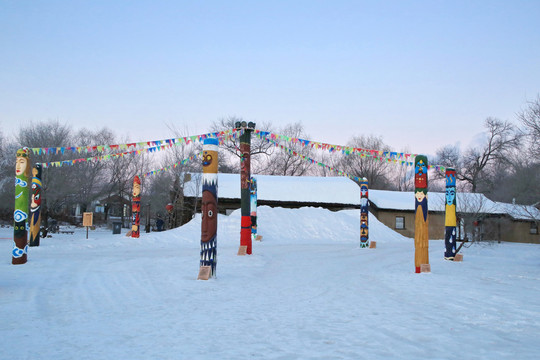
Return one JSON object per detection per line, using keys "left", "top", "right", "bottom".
{"left": 200, "top": 139, "right": 219, "bottom": 277}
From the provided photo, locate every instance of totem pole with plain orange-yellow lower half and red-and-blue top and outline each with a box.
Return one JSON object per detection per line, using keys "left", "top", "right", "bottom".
{"left": 414, "top": 155, "right": 429, "bottom": 273}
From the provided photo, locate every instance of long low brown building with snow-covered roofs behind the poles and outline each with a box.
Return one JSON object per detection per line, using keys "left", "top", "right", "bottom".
{"left": 184, "top": 173, "right": 540, "bottom": 243}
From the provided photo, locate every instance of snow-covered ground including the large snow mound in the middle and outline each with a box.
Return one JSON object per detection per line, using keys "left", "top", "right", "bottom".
{"left": 0, "top": 207, "right": 540, "bottom": 360}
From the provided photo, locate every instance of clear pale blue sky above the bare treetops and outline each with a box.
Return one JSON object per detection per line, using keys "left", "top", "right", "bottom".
{"left": 0, "top": 0, "right": 540, "bottom": 154}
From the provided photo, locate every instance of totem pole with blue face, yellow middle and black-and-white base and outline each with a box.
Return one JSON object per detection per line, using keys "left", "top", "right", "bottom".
{"left": 444, "top": 168, "right": 457, "bottom": 260}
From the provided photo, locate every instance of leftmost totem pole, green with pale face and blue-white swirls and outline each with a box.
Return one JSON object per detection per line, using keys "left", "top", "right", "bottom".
{"left": 11, "top": 148, "right": 30, "bottom": 265}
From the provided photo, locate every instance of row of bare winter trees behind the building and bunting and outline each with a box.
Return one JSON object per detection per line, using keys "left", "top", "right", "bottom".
{"left": 0, "top": 97, "right": 540, "bottom": 227}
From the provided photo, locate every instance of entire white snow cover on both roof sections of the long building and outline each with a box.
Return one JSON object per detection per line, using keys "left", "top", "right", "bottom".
{"left": 184, "top": 173, "right": 540, "bottom": 220}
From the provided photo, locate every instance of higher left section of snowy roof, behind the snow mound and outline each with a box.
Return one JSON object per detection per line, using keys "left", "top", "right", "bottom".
{"left": 185, "top": 173, "right": 360, "bottom": 205}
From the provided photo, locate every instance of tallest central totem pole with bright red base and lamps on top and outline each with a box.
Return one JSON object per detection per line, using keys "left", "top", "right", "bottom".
{"left": 235, "top": 121, "right": 255, "bottom": 255}
